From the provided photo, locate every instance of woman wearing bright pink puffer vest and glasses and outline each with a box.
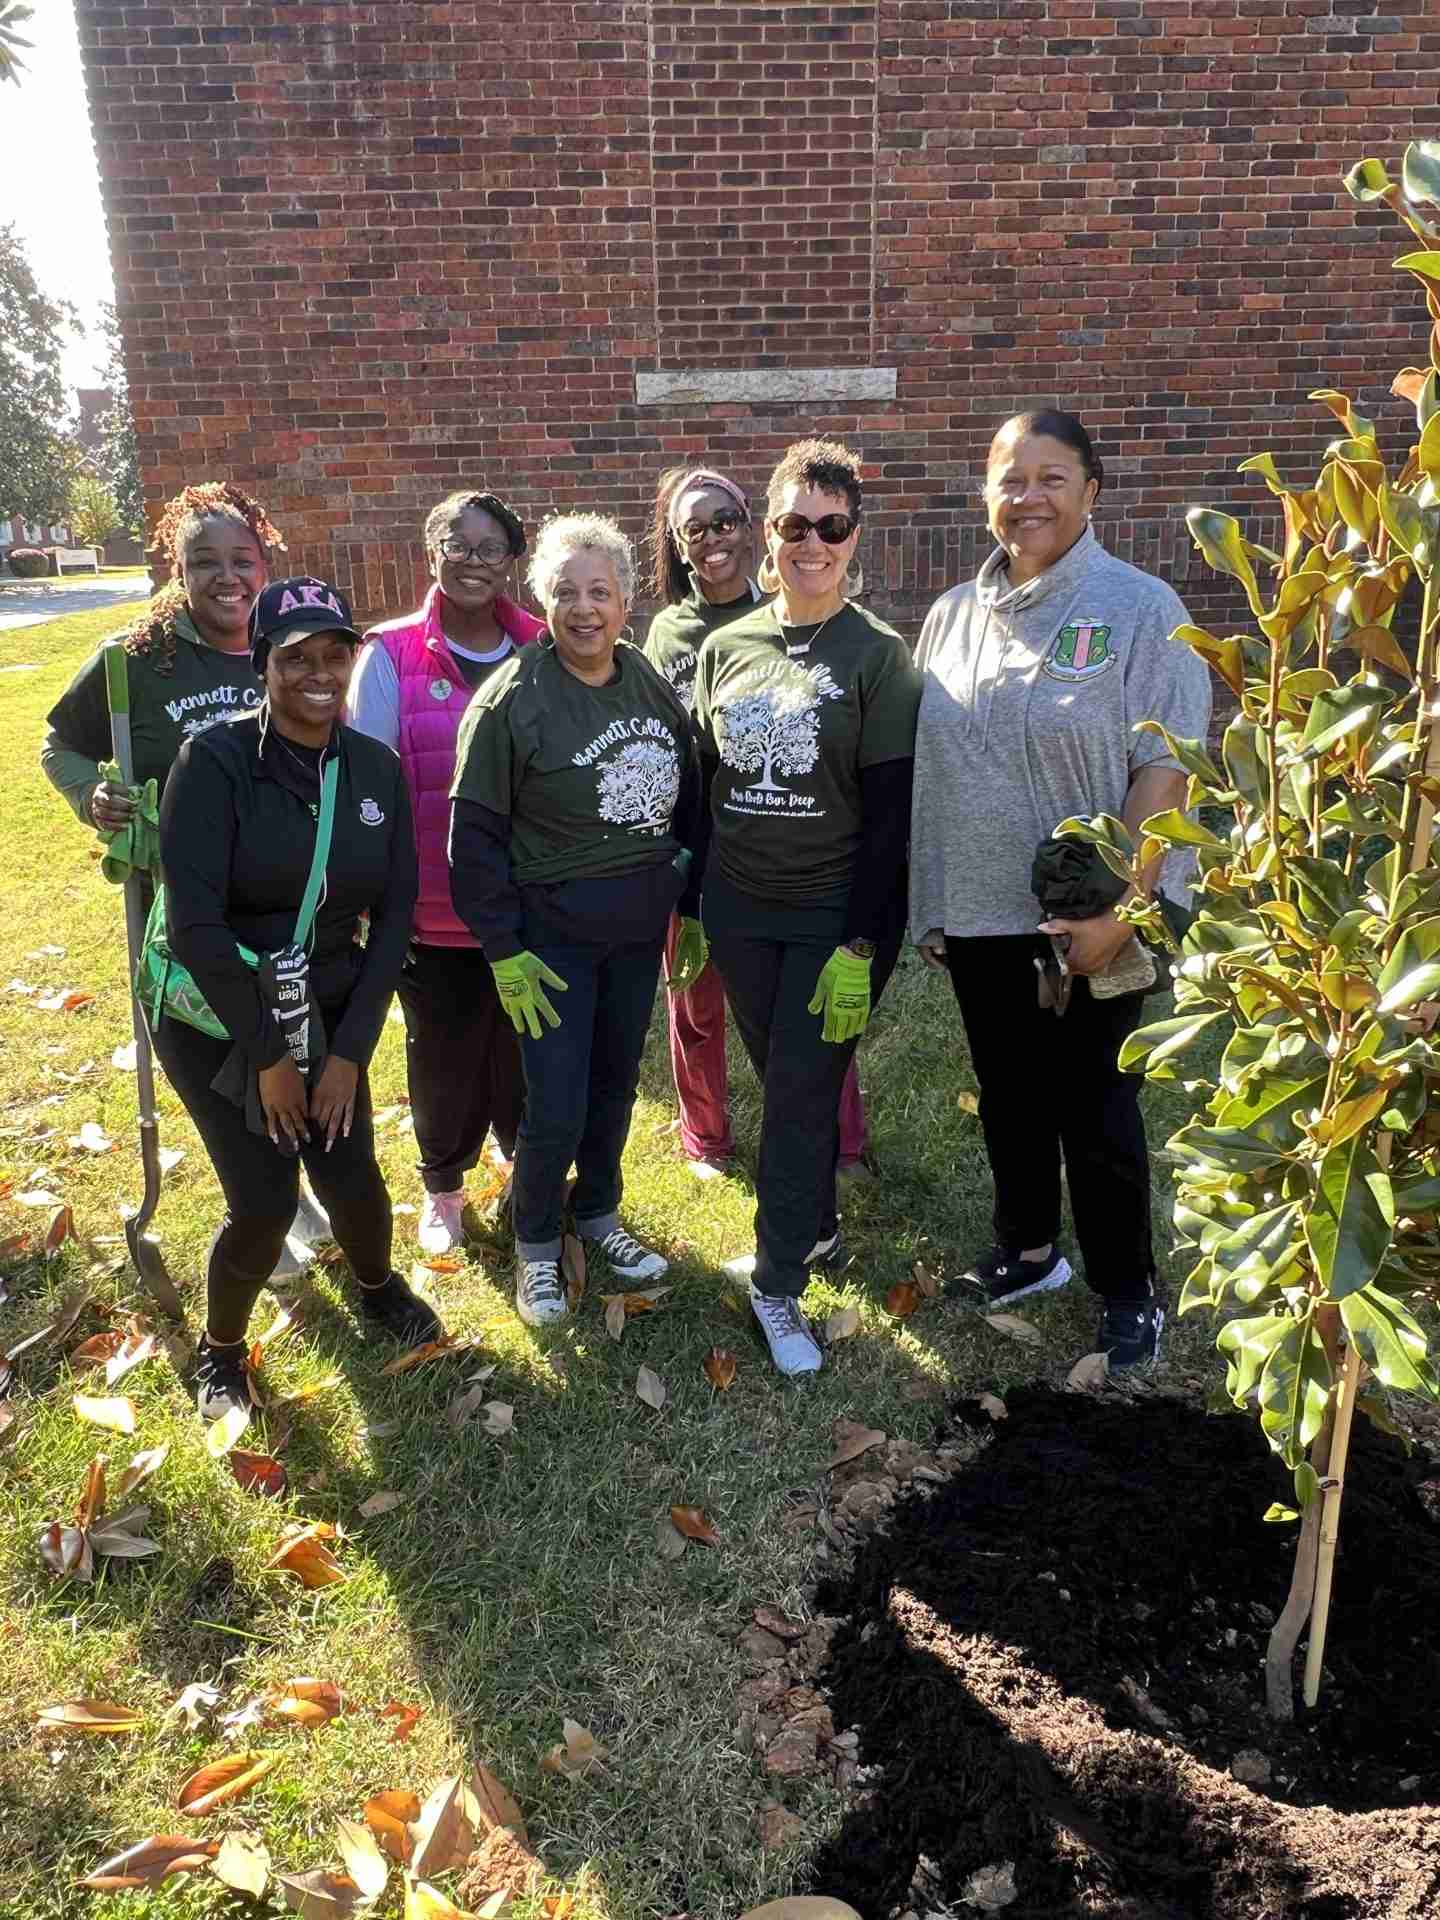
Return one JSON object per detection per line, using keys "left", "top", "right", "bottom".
{"left": 349, "top": 492, "right": 545, "bottom": 1254}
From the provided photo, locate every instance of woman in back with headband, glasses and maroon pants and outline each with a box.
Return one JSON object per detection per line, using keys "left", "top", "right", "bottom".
{"left": 645, "top": 467, "right": 866, "bottom": 1181}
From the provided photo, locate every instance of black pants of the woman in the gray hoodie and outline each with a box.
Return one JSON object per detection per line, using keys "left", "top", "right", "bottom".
{"left": 945, "top": 933, "right": 1156, "bottom": 1300}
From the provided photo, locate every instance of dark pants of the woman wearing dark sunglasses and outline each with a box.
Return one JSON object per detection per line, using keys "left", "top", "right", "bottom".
{"left": 703, "top": 868, "right": 900, "bottom": 1300}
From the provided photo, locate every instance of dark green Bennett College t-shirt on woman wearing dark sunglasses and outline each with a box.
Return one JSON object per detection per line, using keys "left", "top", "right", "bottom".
{"left": 695, "top": 603, "right": 920, "bottom": 906}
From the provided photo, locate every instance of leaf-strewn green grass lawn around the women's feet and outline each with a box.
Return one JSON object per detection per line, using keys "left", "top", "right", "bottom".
{"left": 0, "top": 611, "right": 1217, "bottom": 1920}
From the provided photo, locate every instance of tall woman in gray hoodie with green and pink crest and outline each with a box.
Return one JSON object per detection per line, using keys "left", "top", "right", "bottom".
{"left": 910, "top": 411, "right": 1210, "bottom": 1369}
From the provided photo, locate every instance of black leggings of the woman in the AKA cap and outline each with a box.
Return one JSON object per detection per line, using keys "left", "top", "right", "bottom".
{"left": 156, "top": 1008, "right": 392, "bottom": 1342}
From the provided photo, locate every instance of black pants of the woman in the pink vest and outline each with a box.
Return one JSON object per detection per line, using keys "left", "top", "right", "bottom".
{"left": 397, "top": 943, "right": 524, "bottom": 1194}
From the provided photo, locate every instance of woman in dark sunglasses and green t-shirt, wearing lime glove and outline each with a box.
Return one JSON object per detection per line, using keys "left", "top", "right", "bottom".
{"left": 695, "top": 440, "right": 920, "bottom": 1375}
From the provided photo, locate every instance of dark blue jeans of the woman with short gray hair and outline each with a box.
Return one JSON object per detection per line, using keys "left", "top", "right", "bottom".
{"left": 513, "top": 922, "right": 664, "bottom": 1260}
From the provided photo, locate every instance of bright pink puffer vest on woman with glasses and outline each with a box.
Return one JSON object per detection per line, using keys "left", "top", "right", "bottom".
{"left": 367, "top": 586, "right": 545, "bottom": 947}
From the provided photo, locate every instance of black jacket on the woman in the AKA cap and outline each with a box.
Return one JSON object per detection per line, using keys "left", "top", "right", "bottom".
{"left": 159, "top": 714, "right": 417, "bottom": 1069}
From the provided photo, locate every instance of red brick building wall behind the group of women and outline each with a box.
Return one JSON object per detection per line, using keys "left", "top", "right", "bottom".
{"left": 75, "top": 0, "right": 1440, "bottom": 630}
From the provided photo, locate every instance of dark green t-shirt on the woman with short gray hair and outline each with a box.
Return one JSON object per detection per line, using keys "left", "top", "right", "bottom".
{"left": 451, "top": 641, "right": 693, "bottom": 885}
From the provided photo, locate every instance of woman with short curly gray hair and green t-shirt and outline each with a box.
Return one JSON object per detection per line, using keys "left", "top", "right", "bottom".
{"left": 449, "top": 513, "right": 699, "bottom": 1327}
